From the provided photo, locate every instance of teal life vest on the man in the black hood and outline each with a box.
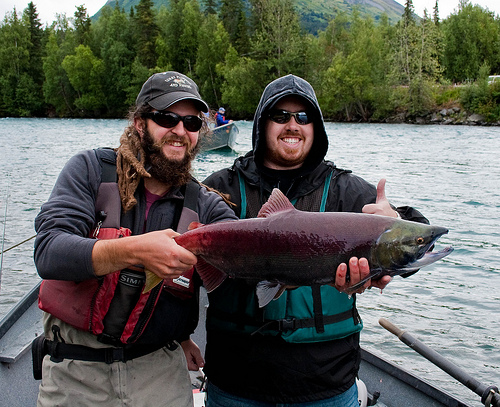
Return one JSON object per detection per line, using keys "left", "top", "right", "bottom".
{"left": 207, "top": 169, "right": 363, "bottom": 343}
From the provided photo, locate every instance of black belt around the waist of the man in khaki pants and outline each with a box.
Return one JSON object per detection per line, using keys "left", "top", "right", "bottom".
{"left": 43, "top": 339, "right": 177, "bottom": 364}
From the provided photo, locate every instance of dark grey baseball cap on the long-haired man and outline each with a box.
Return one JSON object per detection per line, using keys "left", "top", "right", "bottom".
{"left": 135, "top": 71, "right": 208, "bottom": 112}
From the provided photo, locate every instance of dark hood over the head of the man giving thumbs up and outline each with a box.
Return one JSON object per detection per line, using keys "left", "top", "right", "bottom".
{"left": 252, "top": 75, "right": 328, "bottom": 171}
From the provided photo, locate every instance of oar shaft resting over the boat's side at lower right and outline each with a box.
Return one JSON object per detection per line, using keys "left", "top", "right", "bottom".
{"left": 378, "top": 318, "right": 500, "bottom": 407}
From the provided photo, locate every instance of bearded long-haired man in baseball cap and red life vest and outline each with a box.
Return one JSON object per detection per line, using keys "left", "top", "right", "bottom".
{"left": 33, "top": 71, "right": 236, "bottom": 407}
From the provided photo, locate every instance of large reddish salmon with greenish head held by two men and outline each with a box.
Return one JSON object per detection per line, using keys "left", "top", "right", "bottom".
{"left": 145, "top": 189, "right": 453, "bottom": 306}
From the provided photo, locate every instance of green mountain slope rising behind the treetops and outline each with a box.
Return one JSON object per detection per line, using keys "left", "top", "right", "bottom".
{"left": 92, "top": 0, "right": 404, "bottom": 34}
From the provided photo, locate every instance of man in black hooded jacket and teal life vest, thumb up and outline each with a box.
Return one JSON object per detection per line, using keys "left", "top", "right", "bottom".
{"left": 204, "top": 75, "right": 428, "bottom": 407}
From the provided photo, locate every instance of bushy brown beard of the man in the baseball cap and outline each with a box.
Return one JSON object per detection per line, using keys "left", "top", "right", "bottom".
{"left": 141, "top": 128, "right": 199, "bottom": 187}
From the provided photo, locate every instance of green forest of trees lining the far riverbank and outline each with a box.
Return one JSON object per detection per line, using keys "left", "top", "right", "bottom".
{"left": 0, "top": 0, "right": 500, "bottom": 122}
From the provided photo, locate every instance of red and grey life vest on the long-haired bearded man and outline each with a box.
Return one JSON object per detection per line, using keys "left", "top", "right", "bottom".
{"left": 38, "top": 149, "right": 200, "bottom": 345}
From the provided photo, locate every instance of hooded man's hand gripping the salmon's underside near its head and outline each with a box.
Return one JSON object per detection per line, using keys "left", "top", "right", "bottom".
{"left": 335, "top": 257, "right": 392, "bottom": 294}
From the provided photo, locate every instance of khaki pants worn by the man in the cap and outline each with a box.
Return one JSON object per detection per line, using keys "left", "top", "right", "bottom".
{"left": 37, "top": 317, "right": 193, "bottom": 407}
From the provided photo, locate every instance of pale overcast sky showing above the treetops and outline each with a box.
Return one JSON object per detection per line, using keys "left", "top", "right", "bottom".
{"left": 0, "top": 0, "right": 500, "bottom": 24}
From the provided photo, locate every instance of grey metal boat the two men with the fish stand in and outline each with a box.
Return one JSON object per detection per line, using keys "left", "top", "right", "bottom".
{"left": 0, "top": 283, "right": 500, "bottom": 407}
